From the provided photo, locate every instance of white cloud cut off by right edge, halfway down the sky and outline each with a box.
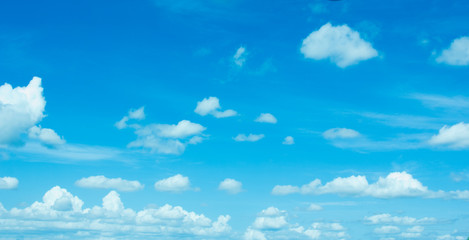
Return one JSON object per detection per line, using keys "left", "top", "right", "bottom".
{"left": 429, "top": 122, "right": 469, "bottom": 149}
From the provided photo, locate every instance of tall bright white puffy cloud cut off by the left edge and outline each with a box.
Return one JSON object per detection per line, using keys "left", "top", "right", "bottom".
{"left": 0, "top": 77, "right": 46, "bottom": 144}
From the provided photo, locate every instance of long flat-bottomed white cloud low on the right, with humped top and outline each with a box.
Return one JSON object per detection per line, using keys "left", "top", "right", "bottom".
{"left": 272, "top": 172, "right": 469, "bottom": 199}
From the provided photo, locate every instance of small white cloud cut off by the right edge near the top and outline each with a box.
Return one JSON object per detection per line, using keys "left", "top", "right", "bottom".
{"left": 436, "top": 37, "right": 469, "bottom": 66}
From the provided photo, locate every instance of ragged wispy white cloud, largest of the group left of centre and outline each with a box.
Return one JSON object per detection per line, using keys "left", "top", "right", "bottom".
{"left": 128, "top": 120, "right": 206, "bottom": 154}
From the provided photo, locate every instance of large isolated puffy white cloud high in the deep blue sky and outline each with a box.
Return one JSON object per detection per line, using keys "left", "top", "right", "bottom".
{"left": 301, "top": 23, "right": 378, "bottom": 68}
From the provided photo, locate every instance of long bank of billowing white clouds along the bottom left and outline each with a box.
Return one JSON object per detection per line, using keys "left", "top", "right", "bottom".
{"left": 0, "top": 186, "right": 231, "bottom": 239}
